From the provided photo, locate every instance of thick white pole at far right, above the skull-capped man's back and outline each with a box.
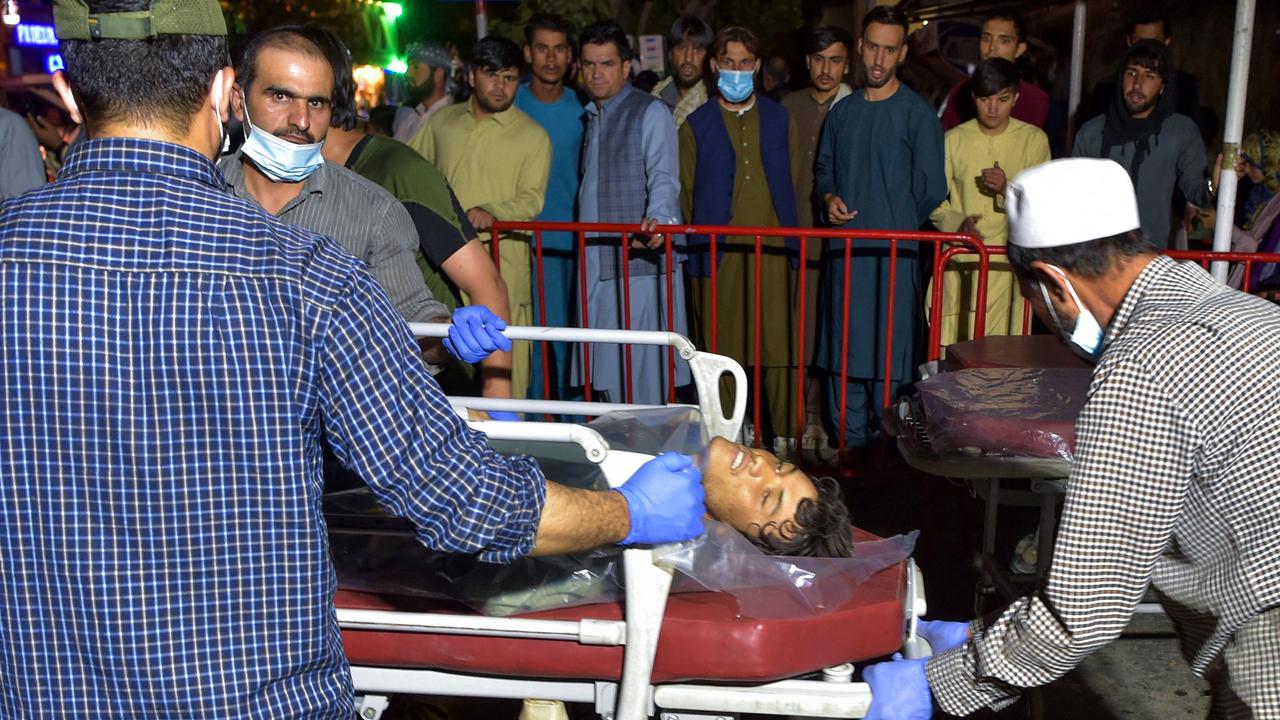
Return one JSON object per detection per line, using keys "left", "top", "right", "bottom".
{"left": 1213, "top": 0, "right": 1254, "bottom": 282}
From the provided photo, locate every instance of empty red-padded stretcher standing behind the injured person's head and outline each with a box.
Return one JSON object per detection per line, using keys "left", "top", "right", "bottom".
{"left": 884, "top": 336, "right": 1092, "bottom": 602}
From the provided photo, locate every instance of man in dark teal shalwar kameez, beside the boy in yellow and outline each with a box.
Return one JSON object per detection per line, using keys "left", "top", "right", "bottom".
{"left": 814, "top": 5, "right": 947, "bottom": 447}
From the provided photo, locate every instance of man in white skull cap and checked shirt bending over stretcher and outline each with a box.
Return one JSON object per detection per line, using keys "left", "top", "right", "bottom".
{"left": 864, "top": 159, "right": 1280, "bottom": 720}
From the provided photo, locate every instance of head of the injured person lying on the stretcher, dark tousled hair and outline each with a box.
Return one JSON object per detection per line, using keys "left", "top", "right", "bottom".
{"left": 700, "top": 430, "right": 854, "bottom": 557}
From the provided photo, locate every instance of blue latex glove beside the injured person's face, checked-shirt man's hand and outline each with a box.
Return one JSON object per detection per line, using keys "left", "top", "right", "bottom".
{"left": 617, "top": 452, "right": 707, "bottom": 544}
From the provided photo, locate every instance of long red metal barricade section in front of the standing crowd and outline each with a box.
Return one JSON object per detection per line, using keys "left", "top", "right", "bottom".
{"left": 492, "top": 223, "right": 988, "bottom": 448}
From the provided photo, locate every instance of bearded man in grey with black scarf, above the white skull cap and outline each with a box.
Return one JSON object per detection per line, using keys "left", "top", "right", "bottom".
{"left": 1071, "top": 40, "right": 1217, "bottom": 249}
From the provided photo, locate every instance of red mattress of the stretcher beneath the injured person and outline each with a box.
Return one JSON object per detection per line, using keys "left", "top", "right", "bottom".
{"left": 334, "top": 529, "right": 906, "bottom": 683}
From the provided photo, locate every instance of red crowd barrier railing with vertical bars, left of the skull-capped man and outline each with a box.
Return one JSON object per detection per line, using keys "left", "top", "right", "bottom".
{"left": 489, "top": 222, "right": 988, "bottom": 448}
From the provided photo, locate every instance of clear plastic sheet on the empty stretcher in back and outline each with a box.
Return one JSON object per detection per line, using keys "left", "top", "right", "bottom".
{"left": 915, "top": 368, "right": 1093, "bottom": 461}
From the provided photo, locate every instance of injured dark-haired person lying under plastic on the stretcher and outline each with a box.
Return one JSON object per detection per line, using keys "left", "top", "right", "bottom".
{"left": 325, "top": 407, "right": 854, "bottom": 615}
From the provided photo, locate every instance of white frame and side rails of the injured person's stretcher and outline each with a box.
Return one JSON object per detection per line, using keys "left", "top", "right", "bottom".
{"left": 337, "top": 323, "right": 929, "bottom": 720}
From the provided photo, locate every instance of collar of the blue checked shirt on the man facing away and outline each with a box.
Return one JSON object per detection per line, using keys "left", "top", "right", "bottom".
{"left": 58, "top": 137, "right": 223, "bottom": 190}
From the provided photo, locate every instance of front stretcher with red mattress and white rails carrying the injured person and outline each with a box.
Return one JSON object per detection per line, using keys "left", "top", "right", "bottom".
{"left": 335, "top": 325, "right": 927, "bottom": 720}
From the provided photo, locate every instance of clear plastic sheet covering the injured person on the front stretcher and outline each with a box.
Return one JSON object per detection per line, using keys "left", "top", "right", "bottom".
{"left": 324, "top": 407, "right": 915, "bottom": 618}
